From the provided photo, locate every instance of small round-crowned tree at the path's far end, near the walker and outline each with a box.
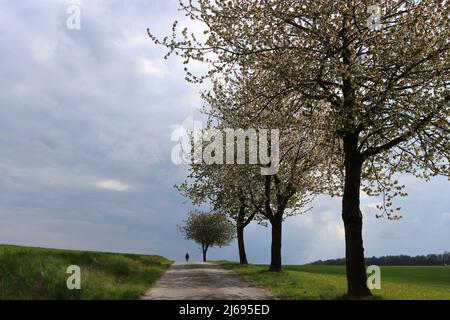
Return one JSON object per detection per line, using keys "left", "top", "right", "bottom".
{"left": 180, "top": 210, "right": 235, "bottom": 262}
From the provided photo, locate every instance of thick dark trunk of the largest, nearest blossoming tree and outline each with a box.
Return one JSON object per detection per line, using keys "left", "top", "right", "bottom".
{"left": 342, "top": 134, "right": 371, "bottom": 298}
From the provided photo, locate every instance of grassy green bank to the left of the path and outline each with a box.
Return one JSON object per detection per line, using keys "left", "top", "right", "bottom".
{"left": 0, "top": 245, "right": 171, "bottom": 300}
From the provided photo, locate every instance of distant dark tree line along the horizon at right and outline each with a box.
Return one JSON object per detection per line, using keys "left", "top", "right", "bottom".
{"left": 311, "top": 252, "right": 450, "bottom": 266}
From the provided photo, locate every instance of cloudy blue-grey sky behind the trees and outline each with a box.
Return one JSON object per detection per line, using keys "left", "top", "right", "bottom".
{"left": 0, "top": 0, "right": 450, "bottom": 263}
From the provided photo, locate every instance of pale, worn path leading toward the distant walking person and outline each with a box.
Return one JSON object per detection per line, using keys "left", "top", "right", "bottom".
{"left": 143, "top": 262, "right": 274, "bottom": 300}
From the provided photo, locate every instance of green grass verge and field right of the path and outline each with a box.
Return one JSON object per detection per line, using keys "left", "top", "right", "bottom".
{"left": 220, "top": 261, "right": 450, "bottom": 300}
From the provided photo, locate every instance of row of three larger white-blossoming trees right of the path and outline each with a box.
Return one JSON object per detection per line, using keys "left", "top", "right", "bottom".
{"left": 149, "top": 0, "right": 450, "bottom": 297}
